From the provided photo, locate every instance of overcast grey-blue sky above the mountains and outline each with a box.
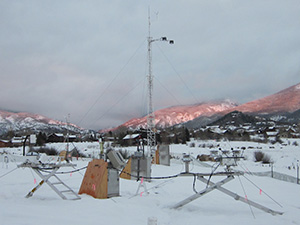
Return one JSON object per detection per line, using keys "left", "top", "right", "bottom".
{"left": 0, "top": 0, "right": 300, "bottom": 129}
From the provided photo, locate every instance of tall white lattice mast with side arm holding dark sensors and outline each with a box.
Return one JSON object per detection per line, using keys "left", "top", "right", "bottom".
{"left": 147, "top": 9, "right": 174, "bottom": 156}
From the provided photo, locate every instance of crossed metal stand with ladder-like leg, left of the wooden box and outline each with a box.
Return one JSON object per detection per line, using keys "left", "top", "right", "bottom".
{"left": 18, "top": 163, "right": 81, "bottom": 200}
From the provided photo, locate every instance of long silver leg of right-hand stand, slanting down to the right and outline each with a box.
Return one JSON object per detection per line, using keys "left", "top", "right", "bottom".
{"left": 198, "top": 176, "right": 283, "bottom": 215}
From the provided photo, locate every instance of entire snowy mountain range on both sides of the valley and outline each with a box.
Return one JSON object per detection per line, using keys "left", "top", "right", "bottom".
{"left": 0, "top": 83, "right": 300, "bottom": 135}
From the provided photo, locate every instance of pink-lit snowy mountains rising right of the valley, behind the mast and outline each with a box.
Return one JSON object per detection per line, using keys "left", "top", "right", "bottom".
{"left": 116, "top": 83, "right": 300, "bottom": 128}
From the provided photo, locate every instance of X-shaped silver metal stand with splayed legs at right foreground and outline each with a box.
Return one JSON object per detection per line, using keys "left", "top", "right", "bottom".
{"left": 172, "top": 173, "right": 283, "bottom": 215}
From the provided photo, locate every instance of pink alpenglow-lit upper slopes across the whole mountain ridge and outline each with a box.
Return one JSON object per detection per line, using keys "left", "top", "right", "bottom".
{"left": 0, "top": 83, "right": 300, "bottom": 132}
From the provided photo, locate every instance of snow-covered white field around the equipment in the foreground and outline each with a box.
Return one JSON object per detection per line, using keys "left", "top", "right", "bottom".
{"left": 0, "top": 139, "right": 300, "bottom": 225}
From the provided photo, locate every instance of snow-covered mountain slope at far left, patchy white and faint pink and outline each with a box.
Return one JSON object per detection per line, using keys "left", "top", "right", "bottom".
{"left": 0, "top": 110, "right": 82, "bottom": 135}
